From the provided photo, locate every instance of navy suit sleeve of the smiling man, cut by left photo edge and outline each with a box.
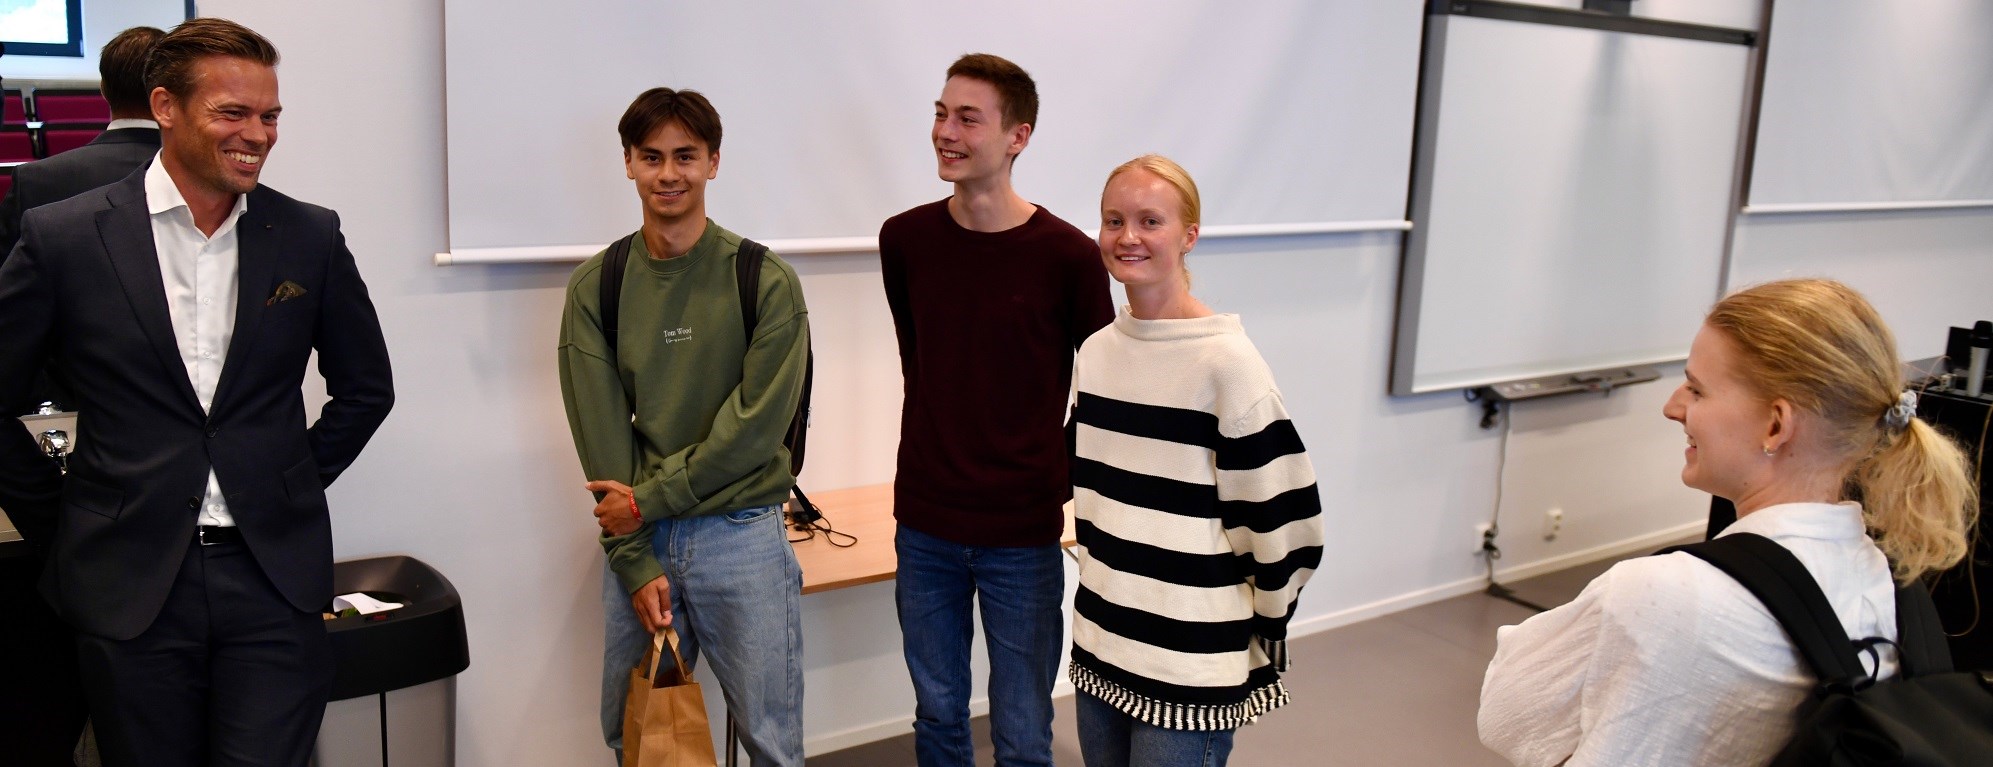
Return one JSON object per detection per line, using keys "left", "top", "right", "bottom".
{"left": 0, "top": 212, "right": 62, "bottom": 542}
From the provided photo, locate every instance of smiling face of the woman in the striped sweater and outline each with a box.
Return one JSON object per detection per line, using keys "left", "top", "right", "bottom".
{"left": 1100, "top": 167, "right": 1198, "bottom": 285}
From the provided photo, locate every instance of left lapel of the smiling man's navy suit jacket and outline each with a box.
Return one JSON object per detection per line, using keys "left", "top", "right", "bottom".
{"left": 98, "top": 171, "right": 201, "bottom": 410}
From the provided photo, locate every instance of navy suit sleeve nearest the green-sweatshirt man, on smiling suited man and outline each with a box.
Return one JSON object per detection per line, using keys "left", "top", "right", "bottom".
{"left": 309, "top": 213, "right": 395, "bottom": 486}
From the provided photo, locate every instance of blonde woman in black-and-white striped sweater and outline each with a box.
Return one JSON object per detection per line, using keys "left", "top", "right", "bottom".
{"left": 1072, "top": 155, "right": 1321, "bottom": 767}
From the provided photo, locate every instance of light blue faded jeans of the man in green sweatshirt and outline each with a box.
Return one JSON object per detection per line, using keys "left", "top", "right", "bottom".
{"left": 602, "top": 506, "right": 803, "bottom": 767}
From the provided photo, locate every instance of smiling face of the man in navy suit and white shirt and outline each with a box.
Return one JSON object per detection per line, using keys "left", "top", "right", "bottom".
{"left": 151, "top": 56, "right": 283, "bottom": 201}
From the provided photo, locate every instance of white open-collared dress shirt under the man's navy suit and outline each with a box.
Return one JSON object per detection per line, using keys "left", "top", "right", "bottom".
{"left": 145, "top": 155, "right": 249, "bottom": 526}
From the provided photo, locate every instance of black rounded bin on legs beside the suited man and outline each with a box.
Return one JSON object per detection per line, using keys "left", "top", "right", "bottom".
{"left": 313, "top": 556, "right": 470, "bottom": 767}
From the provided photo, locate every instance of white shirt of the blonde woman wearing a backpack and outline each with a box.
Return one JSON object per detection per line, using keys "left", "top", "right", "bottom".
{"left": 1479, "top": 504, "right": 1895, "bottom": 767}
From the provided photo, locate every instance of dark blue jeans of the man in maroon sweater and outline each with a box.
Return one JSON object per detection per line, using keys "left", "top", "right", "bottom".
{"left": 893, "top": 526, "right": 1066, "bottom": 767}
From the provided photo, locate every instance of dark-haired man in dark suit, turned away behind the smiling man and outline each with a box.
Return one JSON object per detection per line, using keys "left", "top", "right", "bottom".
{"left": 0, "top": 26, "right": 165, "bottom": 263}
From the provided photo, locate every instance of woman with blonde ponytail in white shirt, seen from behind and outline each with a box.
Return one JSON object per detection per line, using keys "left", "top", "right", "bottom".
{"left": 1479, "top": 279, "right": 1979, "bottom": 765}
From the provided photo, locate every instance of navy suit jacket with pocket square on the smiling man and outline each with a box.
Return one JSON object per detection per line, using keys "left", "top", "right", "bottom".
{"left": 0, "top": 169, "right": 395, "bottom": 639}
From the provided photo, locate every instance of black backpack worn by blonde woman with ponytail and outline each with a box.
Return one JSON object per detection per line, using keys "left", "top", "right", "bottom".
{"left": 1660, "top": 534, "right": 1993, "bottom": 767}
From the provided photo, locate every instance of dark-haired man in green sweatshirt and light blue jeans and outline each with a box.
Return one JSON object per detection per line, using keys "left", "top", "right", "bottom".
{"left": 560, "top": 88, "right": 809, "bottom": 767}
